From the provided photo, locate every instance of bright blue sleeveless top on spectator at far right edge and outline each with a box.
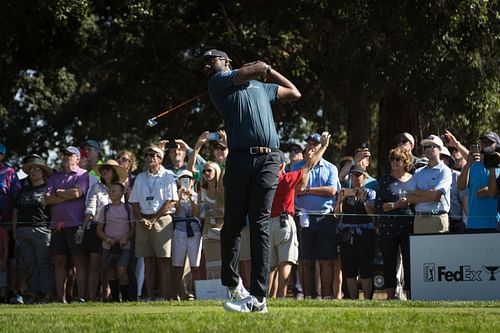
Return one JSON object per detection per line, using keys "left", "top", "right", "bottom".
{"left": 467, "top": 161, "right": 500, "bottom": 229}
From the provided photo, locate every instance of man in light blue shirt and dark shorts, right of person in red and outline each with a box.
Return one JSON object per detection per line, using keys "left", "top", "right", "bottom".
{"left": 292, "top": 133, "right": 342, "bottom": 299}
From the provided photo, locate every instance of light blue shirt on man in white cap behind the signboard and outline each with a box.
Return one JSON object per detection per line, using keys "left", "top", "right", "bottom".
{"left": 411, "top": 161, "right": 452, "bottom": 213}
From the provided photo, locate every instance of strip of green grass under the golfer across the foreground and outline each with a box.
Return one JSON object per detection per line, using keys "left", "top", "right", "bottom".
{"left": 0, "top": 299, "right": 500, "bottom": 333}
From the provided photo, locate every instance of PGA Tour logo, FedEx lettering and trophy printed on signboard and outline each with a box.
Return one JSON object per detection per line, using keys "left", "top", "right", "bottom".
{"left": 423, "top": 263, "right": 500, "bottom": 282}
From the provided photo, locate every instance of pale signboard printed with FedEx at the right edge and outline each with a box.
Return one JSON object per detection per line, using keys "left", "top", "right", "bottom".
{"left": 410, "top": 233, "right": 500, "bottom": 300}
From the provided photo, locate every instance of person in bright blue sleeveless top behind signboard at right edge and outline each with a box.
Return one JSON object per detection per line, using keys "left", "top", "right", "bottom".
{"left": 458, "top": 132, "right": 500, "bottom": 232}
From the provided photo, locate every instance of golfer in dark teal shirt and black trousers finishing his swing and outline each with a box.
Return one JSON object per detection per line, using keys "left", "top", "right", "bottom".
{"left": 203, "top": 49, "right": 301, "bottom": 312}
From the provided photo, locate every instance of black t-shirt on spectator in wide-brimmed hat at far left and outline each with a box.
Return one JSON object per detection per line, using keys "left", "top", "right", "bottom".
{"left": 14, "top": 184, "right": 50, "bottom": 228}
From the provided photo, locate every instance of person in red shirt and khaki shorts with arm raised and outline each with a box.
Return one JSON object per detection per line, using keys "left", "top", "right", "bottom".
{"left": 269, "top": 132, "right": 330, "bottom": 297}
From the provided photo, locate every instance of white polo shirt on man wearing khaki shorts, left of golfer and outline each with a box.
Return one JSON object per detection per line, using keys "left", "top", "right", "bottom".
{"left": 129, "top": 166, "right": 179, "bottom": 215}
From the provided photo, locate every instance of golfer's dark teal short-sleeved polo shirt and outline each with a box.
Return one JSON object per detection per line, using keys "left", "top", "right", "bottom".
{"left": 208, "top": 70, "right": 279, "bottom": 150}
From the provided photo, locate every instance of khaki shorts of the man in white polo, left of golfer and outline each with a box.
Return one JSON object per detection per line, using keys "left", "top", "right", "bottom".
{"left": 135, "top": 215, "right": 174, "bottom": 258}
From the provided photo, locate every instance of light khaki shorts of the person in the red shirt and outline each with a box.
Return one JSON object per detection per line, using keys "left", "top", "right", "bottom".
{"left": 269, "top": 215, "right": 299, "bottom": 267}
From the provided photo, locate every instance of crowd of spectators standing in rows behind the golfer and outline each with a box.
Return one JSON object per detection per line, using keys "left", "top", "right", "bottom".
{"left": 0, "top": 130, "right": 500, "bottom": 304}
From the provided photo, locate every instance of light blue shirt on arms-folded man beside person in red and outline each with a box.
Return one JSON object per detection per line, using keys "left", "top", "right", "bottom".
{"left": 291, "top": 158, "right": 340, "bottom": 213}
